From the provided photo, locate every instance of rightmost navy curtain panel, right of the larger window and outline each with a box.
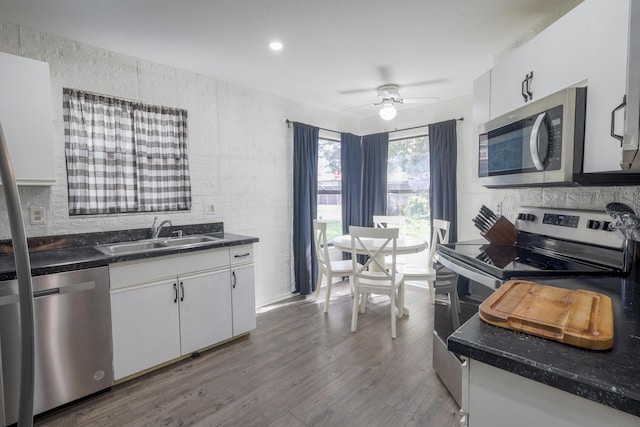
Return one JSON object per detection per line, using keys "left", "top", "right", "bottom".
{"left": 429, "top": 120, "right": 458, "bottom": 242}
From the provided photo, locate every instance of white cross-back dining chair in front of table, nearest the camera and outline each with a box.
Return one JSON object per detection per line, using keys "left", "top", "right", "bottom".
{"left": 349, "top": 226, "right": 404, "bottom": 338}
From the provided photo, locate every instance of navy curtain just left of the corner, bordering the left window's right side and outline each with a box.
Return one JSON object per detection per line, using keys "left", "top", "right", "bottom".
{"left": 340, "top": 133, "right": 362, "bottom": 234}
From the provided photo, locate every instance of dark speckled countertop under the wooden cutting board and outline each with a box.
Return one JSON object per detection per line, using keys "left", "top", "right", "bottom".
{"left": 448, "top": 277, "right": 640, "bottom": 416}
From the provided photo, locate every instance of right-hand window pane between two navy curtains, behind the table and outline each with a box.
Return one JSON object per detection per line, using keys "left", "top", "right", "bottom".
{"left": 387, "top": 136, "right": 430, "bottom": 238}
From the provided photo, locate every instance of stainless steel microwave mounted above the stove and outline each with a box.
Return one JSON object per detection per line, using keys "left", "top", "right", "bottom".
{"left": 478, "top": 87, "right": 587, "bottom": 187}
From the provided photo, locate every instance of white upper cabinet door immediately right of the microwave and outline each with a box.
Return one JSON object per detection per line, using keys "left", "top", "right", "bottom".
{"left": 583, "top": 0, "right": 629, "bottom": 173}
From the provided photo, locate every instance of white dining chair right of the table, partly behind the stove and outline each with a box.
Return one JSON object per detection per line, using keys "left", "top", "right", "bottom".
{"left": 398, "top": 219, "right": 460, "bottom": 324}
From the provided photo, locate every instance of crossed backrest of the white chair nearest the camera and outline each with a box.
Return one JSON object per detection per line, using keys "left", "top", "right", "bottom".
{"left": 349, "top": 225, "right": 399, "bottom": 285}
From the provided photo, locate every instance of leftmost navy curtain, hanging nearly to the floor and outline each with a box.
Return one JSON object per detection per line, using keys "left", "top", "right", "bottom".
{"left": 293, "top": 123, "right": 319, "bottom": 295}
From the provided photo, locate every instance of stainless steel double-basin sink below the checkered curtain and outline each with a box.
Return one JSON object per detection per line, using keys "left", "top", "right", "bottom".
{"left": 95, "top": 234, "right": 224, "bottom": 256}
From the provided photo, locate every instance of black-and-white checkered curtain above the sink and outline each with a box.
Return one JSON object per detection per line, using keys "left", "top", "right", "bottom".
{"left": 64, "top": 89, "right": 191, "bottom": 215}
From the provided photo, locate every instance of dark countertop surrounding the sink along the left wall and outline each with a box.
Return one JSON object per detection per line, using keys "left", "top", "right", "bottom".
{"left": 0, "top": 223, "right": 258, "bottom": 281}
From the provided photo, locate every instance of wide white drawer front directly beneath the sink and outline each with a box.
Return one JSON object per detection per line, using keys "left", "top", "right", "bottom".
{"left": 109, "top": 248, "right": 229, "bottom": 289}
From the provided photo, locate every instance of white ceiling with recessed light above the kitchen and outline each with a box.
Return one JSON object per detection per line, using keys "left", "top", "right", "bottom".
{"left": 0, "top": 0, "right": 581, "bottom": 117}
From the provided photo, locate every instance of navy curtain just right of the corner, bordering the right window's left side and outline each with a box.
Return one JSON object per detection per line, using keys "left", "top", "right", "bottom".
{"left": 360, "top": 132, "right": 389, "bottom": 227}
